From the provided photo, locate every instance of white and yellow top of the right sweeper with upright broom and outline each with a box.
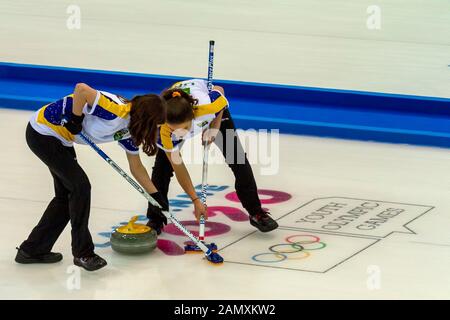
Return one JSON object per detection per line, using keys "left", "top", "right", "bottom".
{"left": 156, "top": 79, "right": 228, "bottom": 152}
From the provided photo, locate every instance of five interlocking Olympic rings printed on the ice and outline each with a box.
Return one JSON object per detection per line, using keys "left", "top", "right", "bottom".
{"left": 252, "top": 234, "right": 327, "bottom": 263}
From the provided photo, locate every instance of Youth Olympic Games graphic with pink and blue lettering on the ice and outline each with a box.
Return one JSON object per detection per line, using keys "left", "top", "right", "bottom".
{"left": 97, "top": 189, "right": 433, "bottom": 273}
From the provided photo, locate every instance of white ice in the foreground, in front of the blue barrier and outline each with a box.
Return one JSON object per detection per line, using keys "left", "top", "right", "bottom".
{"left": 0, "top": 110, "right": 450, "bottom": 299}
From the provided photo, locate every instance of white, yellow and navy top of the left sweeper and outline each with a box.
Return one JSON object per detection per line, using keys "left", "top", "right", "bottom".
{"left": 30, "top": 91, "right": 139, "bottom": 154}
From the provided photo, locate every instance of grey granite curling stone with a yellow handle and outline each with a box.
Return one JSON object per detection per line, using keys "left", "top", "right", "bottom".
{"left": 110, "top": 216, "right": 158, "bottom": 254}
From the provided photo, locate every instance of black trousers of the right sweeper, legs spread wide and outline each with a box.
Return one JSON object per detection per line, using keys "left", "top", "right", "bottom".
{"left": 149, "top": 109, "right": 261, "bottom": 218}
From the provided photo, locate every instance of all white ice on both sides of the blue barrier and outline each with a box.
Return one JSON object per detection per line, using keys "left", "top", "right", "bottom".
{"left": 0, "top": 0, "right": 450, "bottom": 299}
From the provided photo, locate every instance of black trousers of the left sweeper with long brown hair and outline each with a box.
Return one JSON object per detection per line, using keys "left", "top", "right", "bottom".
{"left": 20, "top": 124, "right": 94, "bottom": 257}
